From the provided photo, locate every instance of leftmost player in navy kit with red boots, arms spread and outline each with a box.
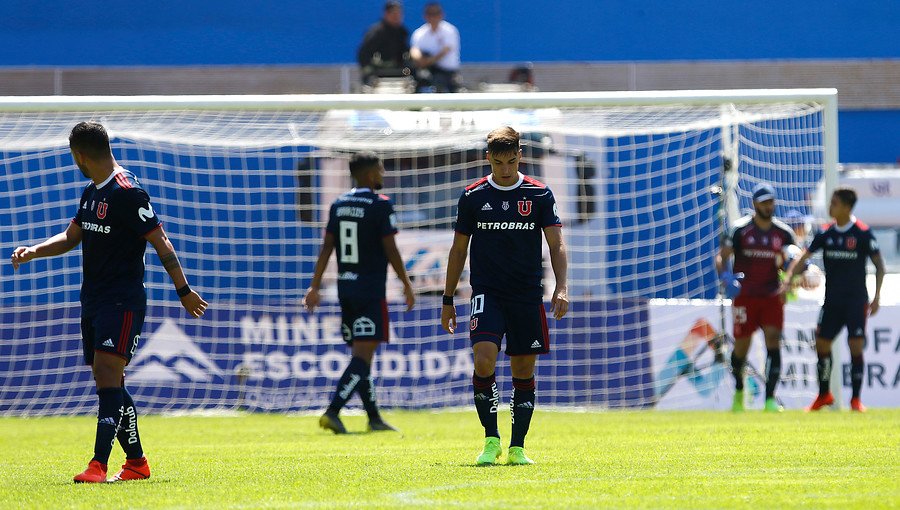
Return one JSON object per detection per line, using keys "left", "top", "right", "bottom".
{"left": 12, "top": 122, "right": 207, "bottom": 483}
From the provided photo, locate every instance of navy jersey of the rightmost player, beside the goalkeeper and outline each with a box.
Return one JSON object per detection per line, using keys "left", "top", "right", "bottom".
{"left": 809, "top": 218, "right": 879, "bottom": 301}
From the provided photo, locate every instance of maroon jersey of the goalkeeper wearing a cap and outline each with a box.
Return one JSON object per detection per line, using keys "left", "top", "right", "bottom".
{"left": 725, "top": 216, "right": 797, "bottom": 297}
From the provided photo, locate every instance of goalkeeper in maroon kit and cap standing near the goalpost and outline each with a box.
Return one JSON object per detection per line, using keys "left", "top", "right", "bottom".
{"left": 716, "top": 183, "right": 797, "bottom": 412}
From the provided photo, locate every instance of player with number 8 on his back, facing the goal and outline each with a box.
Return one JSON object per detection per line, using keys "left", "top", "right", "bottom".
{"left": 303, "top": 152, "right": 416, "bottom": 434}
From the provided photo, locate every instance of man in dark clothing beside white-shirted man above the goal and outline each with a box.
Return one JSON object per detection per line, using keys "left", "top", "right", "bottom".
{"left": 356, "top": 0, "right": 410, "bottom": 85}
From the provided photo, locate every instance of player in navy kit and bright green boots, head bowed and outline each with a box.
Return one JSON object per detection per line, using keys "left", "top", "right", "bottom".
{"left": 441, "top": 127, "right": 569, "bottom": 464}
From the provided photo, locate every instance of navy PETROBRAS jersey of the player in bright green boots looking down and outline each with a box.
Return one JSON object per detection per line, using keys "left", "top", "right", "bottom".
{"left": 456, "top": 174, "right": 562, "bottom": 302}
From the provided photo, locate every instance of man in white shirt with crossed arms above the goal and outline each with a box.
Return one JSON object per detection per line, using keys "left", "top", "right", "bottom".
{"left": 409, "top": 2, "right": 459, "bottom": 92}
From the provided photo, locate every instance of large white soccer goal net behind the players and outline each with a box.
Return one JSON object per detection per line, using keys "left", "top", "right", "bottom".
{"left": 0, "top": 89, "right": 837, "bottom": 414}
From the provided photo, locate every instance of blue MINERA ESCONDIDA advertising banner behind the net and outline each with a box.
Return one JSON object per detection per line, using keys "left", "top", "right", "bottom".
{"left": 0, "top": 298, "right": 653, "bottom": 414}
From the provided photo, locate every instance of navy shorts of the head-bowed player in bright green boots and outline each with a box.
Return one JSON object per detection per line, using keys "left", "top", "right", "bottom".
{"left": 469, "top": 293, "right": 550, "bottom": 356}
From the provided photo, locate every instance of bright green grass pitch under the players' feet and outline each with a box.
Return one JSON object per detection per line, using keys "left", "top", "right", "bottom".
{"left": 0, "top": 408, "right": 900, "bottom": 510}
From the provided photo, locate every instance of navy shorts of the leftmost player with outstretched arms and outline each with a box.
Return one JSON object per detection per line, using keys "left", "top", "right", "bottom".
{"left": 81, "top": 310, "right": 146, "bottom": 365}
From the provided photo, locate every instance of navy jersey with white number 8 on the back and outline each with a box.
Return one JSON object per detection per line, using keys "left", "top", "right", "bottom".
{"left": 325, "top": 188, "right": 397, "bottom": 299}
